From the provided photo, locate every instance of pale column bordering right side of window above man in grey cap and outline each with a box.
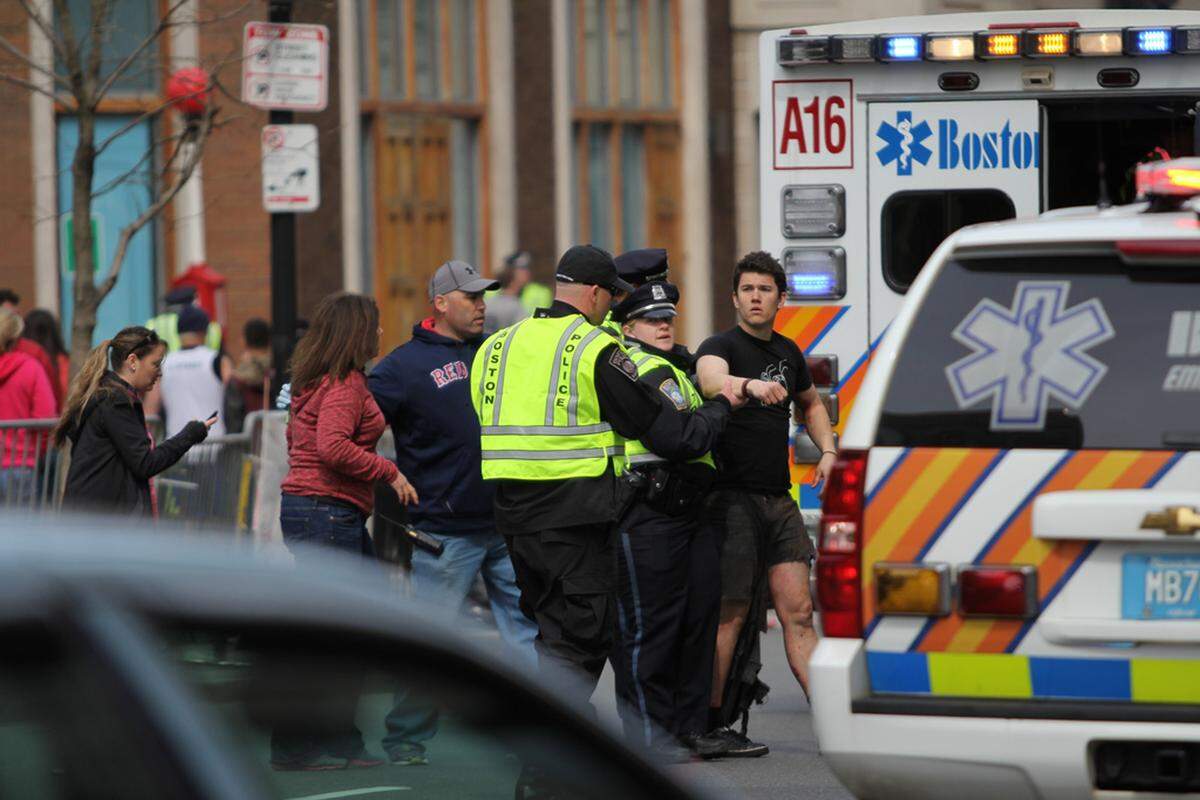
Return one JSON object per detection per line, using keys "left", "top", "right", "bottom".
{"left": 476, "top": 0, "right": 518, "bottom": 273}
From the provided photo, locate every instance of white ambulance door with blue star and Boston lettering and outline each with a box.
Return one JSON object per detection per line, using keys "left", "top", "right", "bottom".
{"left": 866, "top": 100, "right": 1043, "bottom": 343}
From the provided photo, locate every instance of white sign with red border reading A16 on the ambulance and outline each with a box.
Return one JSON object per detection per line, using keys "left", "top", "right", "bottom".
{"left": 772, "top": 80, "right": 854, "bottom": 169}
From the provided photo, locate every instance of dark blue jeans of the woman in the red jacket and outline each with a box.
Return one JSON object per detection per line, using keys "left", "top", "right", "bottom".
{"left": 271, "top": 494, "right": 374, "bottom": 766}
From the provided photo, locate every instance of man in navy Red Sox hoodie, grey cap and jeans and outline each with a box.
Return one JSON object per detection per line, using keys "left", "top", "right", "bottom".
{"left": 367, "top": 261, "right": 538, "bottom": 764}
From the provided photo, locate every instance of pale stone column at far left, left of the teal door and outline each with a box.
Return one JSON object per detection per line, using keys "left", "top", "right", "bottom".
{"left": 29, "top": 0, "right": 61, "bottom": 314}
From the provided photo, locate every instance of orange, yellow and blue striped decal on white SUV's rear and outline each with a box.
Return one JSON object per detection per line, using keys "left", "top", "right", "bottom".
{"left": 863, "top": 447, "right": 1182, "bottom": 652}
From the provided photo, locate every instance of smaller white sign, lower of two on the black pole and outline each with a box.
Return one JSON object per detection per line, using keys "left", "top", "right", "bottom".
{"left": 263, "top": 125, "right": 320, "bottom": 213}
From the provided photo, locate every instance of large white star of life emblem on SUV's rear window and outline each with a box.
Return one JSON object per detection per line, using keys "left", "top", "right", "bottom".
{"left": 946, "top": 281, "right": 1115, "bottom": 431}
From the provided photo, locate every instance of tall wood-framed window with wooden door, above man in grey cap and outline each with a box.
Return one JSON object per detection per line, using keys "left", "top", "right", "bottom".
{"left": 360, "top": 0, "right": 487, "bottom": 348}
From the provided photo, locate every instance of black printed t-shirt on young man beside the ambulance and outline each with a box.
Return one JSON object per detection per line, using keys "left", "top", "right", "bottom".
{"left": 696, "top": 327, "right": 812, "bottom": 494}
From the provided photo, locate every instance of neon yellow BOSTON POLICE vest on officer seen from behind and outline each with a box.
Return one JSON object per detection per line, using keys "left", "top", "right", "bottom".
{"left": 470, "top": 314, "right": 625, "bottom": 481}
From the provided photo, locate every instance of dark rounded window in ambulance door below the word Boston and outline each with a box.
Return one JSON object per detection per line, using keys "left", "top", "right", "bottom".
{"left": 882, "top": 190, "right": 1016, "bottom": 294}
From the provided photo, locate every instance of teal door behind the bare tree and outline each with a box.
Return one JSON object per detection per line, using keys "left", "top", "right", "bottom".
{"left": 58, "top": 116, "right": 155, "bottom": 343}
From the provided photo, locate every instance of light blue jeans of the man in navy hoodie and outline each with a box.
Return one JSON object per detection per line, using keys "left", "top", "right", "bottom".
{"left": 383, "top": 530, "right": 538, "bottom": 752}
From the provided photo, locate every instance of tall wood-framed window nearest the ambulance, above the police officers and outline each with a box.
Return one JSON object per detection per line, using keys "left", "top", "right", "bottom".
{"left": 568, "top": 0, "right": 679, "bottom": 252}
